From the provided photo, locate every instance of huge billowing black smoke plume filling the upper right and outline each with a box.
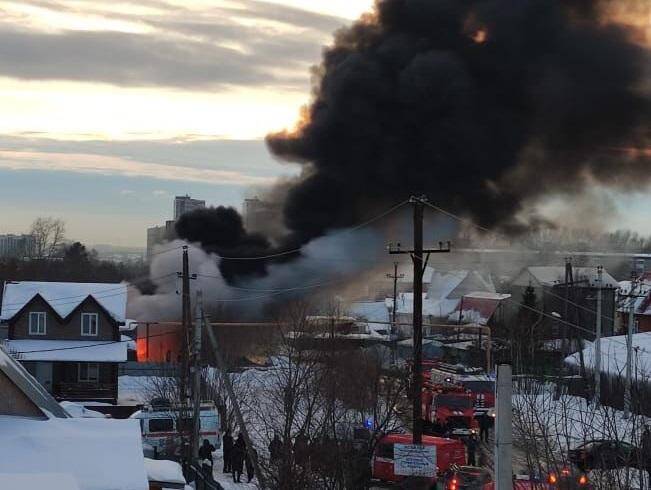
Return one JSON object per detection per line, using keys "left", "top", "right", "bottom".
{"left": 267, "top": 0, "right": 650, "bottom": 241}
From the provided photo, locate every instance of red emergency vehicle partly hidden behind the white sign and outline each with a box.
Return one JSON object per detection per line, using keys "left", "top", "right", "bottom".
{"left": 373, "top": 434, "right": 466, "bottom": 483}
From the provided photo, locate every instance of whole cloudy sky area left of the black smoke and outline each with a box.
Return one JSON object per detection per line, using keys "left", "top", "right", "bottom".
{"left": 0, "top": 0, "right": 372, "bottom": 245}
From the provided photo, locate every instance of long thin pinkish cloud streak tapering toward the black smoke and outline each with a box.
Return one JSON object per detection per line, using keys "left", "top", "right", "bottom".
{"left": 0, "top": 146, "right": 273, "bottom": 186}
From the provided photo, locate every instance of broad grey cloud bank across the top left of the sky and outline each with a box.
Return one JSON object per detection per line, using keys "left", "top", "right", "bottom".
{"left": 0, "top": 0, "right": 345, "bottom": 90}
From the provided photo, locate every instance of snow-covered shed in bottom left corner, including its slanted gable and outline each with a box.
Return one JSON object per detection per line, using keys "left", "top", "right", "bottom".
{"left": 0, "top": 346, "right": 148, "bottom": 490}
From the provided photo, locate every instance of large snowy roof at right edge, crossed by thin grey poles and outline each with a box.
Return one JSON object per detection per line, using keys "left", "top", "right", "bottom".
{"left": 565, "top": 332, "right": 651, "bottom": 378}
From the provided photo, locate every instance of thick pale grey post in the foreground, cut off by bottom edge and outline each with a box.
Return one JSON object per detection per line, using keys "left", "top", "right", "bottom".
{"left": 495, "top": 364, "right": 513, "bottom": 490}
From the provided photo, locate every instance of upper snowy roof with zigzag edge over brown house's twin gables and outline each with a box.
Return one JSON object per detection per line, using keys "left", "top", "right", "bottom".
{"left": 0, "top": 281, "right": 127, "bottom": 322}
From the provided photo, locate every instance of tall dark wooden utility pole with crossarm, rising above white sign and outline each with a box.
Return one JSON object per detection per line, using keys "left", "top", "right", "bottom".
{"left": 389, "top": 196, "right": 450, "bottom": 444}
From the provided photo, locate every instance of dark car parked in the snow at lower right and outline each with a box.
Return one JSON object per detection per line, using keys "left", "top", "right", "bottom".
{"left": 567, "top": 440, "right": 639, "bottom": 471}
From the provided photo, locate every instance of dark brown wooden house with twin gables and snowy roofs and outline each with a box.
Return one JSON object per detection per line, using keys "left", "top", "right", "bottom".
{"left": 0, "top": 282, "right": 127, "bottom": 403}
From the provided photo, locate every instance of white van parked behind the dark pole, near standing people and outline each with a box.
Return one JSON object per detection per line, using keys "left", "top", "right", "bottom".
{"left": 131, "top": 401, "right": 221, "bottom": 457}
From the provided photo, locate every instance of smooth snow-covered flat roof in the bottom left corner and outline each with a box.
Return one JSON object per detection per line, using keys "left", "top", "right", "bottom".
{"left": 0, "top": 415, "right": 149, "bottom": 490}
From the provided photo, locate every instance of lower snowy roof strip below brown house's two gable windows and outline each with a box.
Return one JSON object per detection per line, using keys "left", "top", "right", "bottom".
{"left": 5, "top": 339, "right": 128, "bottom": 362}
